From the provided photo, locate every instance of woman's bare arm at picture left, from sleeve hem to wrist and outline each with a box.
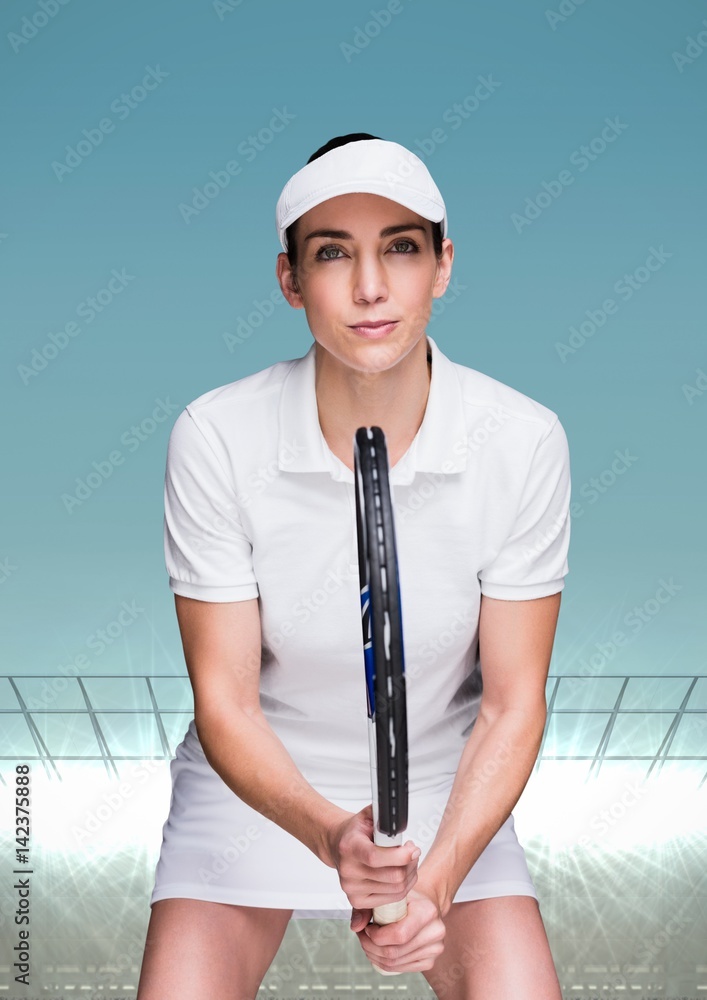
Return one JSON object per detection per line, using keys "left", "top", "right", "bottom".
{"left": 175, "top": 594, "right": 351, "bottom": 868}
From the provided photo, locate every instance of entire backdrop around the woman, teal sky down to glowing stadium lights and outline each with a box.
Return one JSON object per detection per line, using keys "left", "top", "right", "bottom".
{"left": 0, "top": 0, "right": 707, "bottom": 1000}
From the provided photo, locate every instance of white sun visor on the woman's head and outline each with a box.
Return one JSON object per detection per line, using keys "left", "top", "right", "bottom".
{"left": 275, "top": 139, "right": 447, "bottom": 250}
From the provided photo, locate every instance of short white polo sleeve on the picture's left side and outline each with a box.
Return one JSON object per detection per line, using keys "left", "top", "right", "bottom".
{"left": 164, "top": 408, "right": 259, "bottom": 602}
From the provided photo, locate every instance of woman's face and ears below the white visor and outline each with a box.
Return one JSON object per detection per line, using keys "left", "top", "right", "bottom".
{"left": 277, "top": 194, "right": 454, "bottom": 372}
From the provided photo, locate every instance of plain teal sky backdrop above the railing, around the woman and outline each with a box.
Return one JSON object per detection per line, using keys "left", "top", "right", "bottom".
{"left": 0, "top": 0, "right": 707, "bottom": 675}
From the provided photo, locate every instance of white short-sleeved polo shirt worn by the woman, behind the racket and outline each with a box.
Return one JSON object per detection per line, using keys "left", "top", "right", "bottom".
{"left": 165, "top": 335, "right": 570, "bottom": 801}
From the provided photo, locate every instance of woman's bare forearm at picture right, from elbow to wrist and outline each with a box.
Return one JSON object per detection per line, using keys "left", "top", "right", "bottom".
{"left": 419, "top": 703, "right": 546, "bottom": 914}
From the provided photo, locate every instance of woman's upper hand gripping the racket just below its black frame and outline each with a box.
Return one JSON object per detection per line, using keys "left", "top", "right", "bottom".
{"left": 329, "top": 804, "right": 420, "bottom": 910}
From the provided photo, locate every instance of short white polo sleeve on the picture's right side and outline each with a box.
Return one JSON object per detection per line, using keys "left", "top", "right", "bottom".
{"left": 479, "top": 417, "right": 571, "bottom": 601}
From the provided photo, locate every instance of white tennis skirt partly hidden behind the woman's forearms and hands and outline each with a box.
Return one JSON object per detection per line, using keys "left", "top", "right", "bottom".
{"left": 150, "top": 720, "right": 537, "bottom": 920}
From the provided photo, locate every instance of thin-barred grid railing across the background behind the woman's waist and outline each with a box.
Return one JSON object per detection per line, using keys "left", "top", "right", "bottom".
{"left": 0, "top": 674, "right": 707, "bottom": 787}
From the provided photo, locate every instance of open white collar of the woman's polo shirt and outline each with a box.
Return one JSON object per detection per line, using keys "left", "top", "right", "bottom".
{"left": 278, "top": 334, "right": 467, "bottom": 485}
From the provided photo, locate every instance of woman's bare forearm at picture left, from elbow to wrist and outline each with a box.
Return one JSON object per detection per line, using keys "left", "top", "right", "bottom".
{"left": 195, "top": 705, "right": 350, "bottom": 867}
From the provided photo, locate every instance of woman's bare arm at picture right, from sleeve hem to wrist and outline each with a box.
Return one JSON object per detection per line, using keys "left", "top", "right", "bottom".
{"left": 415, "top": 592, "right": 562, "bottom": 916}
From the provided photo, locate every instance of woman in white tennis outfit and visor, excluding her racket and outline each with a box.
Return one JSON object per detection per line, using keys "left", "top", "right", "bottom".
{"left": 138, "top": 133, "right": 570, "bottom": 1000}
